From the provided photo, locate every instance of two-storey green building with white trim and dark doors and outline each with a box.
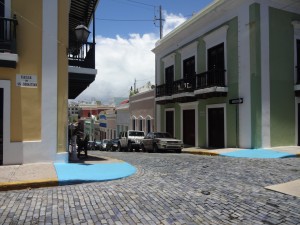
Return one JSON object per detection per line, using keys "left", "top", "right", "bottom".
{"left": 153, "top": 0, "right": 300, "bottom": 148}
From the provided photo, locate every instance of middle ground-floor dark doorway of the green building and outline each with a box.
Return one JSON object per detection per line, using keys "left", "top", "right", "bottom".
{"left": 183, "top": 109, "right": 195, "bottom": 146}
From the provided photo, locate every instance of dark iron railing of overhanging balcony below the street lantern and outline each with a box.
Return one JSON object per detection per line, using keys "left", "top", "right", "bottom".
{"left": 68, "top": 42, "right": 95, "bottom": 69}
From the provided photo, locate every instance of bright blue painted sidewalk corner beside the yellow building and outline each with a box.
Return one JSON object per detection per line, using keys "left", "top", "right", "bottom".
{"left": 54, "top": 162, "right": 136, "bottom": 185}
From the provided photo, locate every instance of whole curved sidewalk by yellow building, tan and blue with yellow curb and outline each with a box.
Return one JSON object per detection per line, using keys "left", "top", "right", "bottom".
{"left": 0, "top": 154, "right": 136, "bottom": 191}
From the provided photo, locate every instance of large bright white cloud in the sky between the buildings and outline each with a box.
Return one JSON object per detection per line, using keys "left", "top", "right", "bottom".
{"left": 77, "top": 13, "right": 185, "bottom": 103}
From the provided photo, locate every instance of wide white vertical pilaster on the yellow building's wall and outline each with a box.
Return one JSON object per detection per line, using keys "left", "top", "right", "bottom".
{"left": 41, "top": 0, "right": 58, "bottom": 155}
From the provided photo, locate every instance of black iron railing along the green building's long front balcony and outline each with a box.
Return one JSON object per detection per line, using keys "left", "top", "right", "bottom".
{"left": 156, "top": 69, "right": 226, "bottom": 97}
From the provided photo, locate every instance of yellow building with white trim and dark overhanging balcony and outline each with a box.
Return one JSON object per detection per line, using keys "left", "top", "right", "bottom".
{"left": 0, "top": 0, "right": 99, "bottom": 165}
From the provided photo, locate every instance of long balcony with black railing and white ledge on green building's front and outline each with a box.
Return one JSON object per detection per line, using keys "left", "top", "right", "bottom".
{"left": 156, "top": 69, "right": 228, "bottom": 104}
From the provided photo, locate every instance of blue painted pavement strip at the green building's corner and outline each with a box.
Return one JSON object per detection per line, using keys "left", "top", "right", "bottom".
{"left": 220, "top": 149, "right": 297, "bottom": 159}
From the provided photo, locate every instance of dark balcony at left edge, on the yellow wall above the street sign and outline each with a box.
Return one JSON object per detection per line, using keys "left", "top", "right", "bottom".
{"left": 0, "top": 16, "right": 18, "bottom": 68}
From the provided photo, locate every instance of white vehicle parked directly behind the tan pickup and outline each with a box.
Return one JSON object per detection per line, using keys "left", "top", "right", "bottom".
{"left": 118, "top": 130, "right": 145, "bottom": 151}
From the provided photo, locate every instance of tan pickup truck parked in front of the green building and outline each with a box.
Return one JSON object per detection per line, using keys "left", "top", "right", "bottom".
{"left": 141, "top": 132, "right": 183, "bottom": 153}
